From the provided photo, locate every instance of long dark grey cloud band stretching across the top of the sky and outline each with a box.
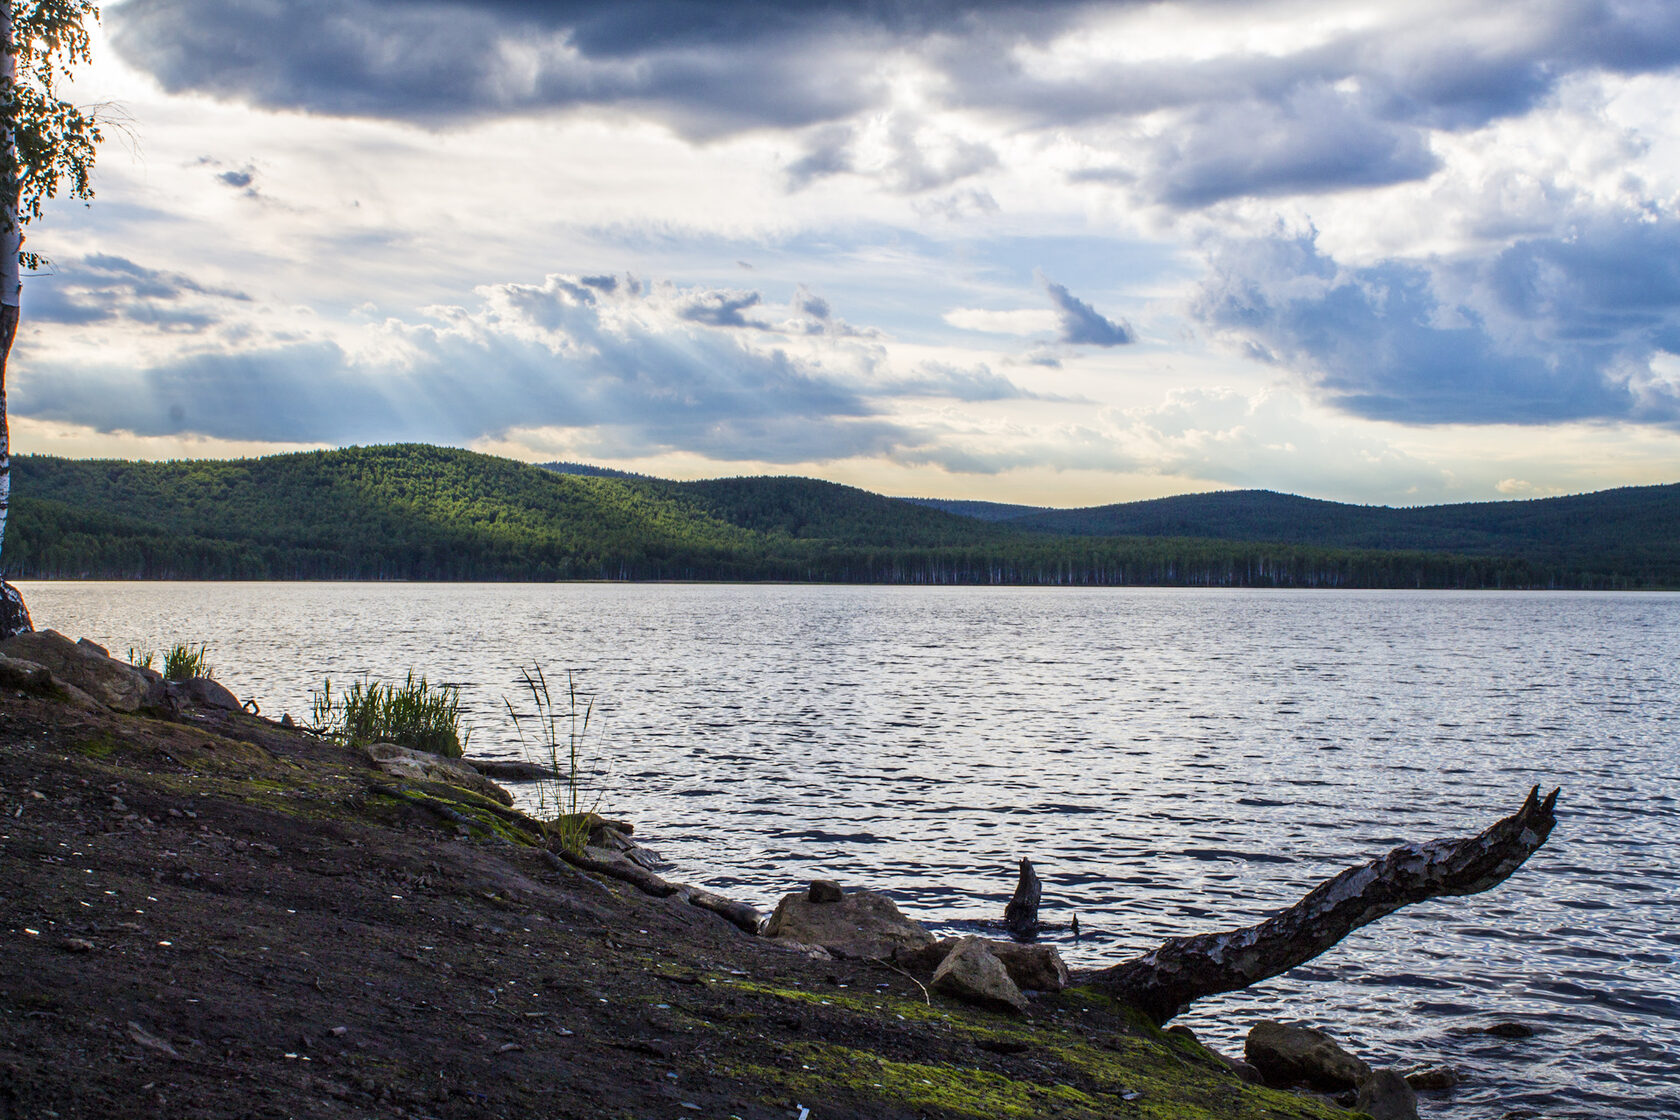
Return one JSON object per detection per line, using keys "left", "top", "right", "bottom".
{"left": 108, "top": 0, "right": 1680, "bottom": 208}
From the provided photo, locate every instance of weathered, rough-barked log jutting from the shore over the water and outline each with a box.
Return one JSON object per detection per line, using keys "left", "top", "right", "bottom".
{"left": 1084, "top": 786, "right": 1559, "bottom": 1023}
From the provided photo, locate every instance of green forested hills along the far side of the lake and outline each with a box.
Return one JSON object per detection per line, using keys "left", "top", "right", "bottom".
{"left": 5, "top": 445, "right": 1680, "bottom": 588}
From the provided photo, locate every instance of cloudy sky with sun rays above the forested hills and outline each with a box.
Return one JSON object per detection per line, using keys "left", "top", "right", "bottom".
{"left": 8, "top": 0, "right": 1680, "bottom": 505}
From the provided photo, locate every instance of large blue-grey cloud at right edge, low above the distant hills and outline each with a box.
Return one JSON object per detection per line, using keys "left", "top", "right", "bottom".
{"left": 1198, "top": 222, "right": 1680, "bottom": 425}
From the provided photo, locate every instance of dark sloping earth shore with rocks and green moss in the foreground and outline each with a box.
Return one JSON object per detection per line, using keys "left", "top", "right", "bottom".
{"left": 0, "top": 635, "right": 1374, "bottom": 1120}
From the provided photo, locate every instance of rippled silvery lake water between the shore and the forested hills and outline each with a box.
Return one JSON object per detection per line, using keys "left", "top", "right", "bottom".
{"left": 22, "top": 583, "right": 1680, "bottom": 1120}
